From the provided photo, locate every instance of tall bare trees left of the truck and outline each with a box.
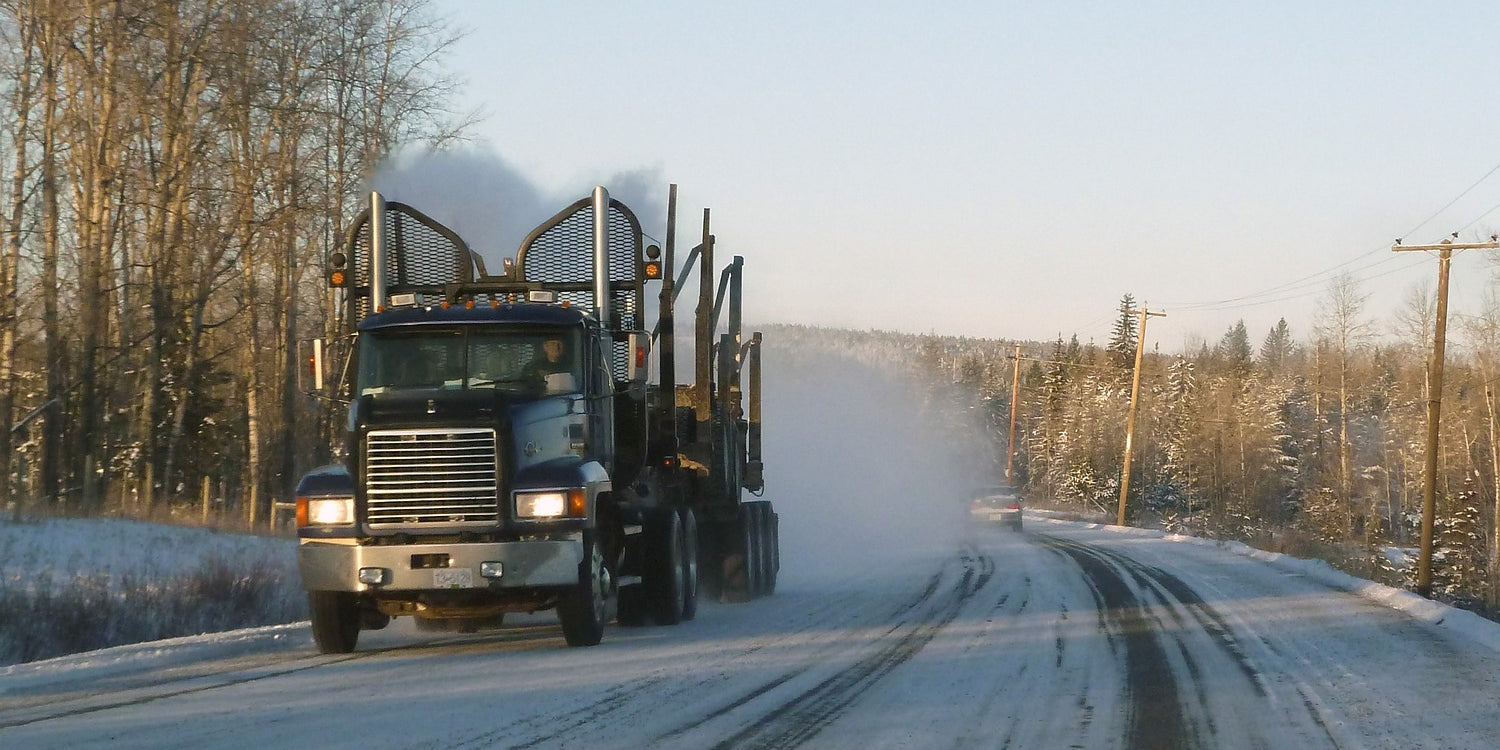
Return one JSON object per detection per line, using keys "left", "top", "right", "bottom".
{"left": 0, "top": 0, "right": 465, "bottom": 518}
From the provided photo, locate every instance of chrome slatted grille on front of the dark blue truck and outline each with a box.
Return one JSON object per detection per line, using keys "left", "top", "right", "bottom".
{"left": 365, "top": 429, "right": 500, "bottom": 528}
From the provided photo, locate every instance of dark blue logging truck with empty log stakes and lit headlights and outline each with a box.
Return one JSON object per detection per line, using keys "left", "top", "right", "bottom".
{"left": 297, "top": 186, "right": 780, "bottom": 653}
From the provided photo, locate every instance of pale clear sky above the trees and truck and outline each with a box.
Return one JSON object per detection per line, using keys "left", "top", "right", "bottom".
{"left": 414, "top": 0, "right": 1500, "bottom": 351}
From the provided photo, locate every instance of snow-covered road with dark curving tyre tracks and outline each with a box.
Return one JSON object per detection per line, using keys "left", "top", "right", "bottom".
{"left": 0, "top": 518, "right": 1500, "bottom": 750}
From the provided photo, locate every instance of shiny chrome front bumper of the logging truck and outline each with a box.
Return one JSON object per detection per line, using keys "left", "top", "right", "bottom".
{"left": 297, "top": 534, "right": 584, "bottom": 591}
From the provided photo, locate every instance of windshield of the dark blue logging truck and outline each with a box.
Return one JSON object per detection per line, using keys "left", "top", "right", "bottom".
{"left": 359, "top": 326, "right": 584, "bottom": 396}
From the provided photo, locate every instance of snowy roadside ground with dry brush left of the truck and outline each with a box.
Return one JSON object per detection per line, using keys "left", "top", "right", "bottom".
{"left": 0, "top": 519, "right": 308, "bottom": 665}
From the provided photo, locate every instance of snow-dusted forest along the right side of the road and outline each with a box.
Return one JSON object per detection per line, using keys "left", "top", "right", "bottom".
{"left": 768, "top": 276, "right": 1500, "bottom": 612}
